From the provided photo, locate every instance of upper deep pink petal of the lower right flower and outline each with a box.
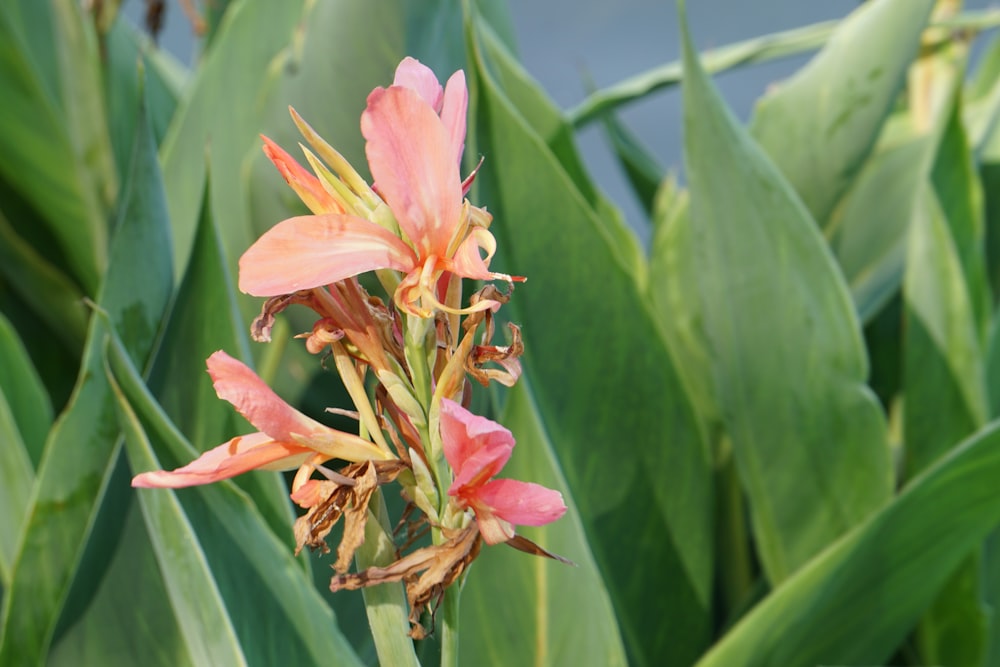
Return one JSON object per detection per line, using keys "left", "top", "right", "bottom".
{"left": 441, "top": 398, "right": 514, "bottom": 482}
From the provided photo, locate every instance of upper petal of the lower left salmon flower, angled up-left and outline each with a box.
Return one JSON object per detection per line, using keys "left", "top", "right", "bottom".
{"left": 206, "top": 350, "right": 330, "bottom": 442}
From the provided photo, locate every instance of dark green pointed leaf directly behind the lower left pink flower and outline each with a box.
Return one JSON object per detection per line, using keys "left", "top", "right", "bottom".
{"left": 149, "top": 183, "right": 294, "bottom": 544}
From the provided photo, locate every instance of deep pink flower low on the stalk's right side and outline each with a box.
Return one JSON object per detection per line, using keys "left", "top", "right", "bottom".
{"left": 441, "top": 399, "right": 566, "bottom": 544}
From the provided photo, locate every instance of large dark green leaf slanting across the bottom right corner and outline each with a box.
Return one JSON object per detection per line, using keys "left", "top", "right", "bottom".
{"left": 698, "top": 422, "right": 1000, "bottom": 667}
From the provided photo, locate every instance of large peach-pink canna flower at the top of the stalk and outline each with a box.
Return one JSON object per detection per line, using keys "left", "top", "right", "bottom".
{"left": 239, "top": 58, "right": 514, "bottom": 317}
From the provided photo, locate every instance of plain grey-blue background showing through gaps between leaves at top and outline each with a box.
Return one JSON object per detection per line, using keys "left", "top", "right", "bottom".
{"left": 123, "top": 0, "right": 997, "bottom": 237}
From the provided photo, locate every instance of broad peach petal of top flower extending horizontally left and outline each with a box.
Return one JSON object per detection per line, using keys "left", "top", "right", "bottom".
{"left": 240, "top": 214, "right": 416, "bottom": 296}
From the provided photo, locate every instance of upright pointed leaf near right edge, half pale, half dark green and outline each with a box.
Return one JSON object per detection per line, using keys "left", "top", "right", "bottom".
{"left": 903, "top": 90, "right": 989, "bottom": 665}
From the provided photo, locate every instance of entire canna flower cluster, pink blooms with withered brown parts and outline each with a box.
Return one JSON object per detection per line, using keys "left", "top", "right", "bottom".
{"left": 132, "top": 58, "right": 566, "bottom": 638}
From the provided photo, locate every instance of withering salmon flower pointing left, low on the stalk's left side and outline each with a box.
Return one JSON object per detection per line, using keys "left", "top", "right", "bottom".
{"left": 132, "top": 350, "right": 392, "bottom": 489}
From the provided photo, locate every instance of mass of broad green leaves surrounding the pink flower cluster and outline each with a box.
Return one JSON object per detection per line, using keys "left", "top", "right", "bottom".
{"left": 0, "top": 0, "right": 1000, "bottom": 667}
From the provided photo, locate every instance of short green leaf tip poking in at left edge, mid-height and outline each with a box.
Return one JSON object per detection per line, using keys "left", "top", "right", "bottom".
{"left": 0, "top": 313, "right": 53, "bottom": 470}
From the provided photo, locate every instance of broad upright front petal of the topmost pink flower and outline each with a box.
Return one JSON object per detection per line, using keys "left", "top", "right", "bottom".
{"left": 361, "top": 87, "right": 462, "bottom": 259}
